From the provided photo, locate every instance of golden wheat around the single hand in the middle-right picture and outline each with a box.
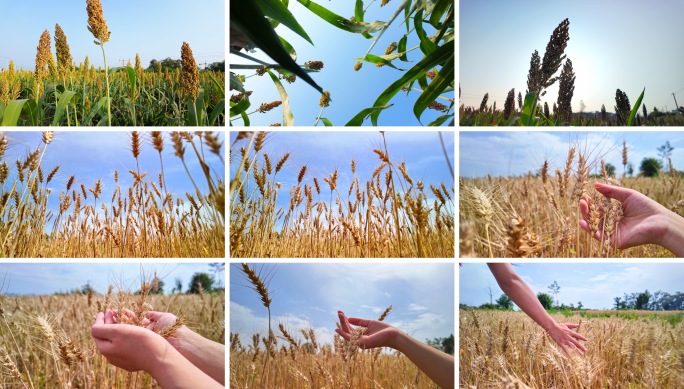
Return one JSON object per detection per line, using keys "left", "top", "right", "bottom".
{"left": 459, "top": 142, "right": 683, "bottom": 258}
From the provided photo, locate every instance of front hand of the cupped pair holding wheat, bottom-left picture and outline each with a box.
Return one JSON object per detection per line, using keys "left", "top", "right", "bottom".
{"left": 90, "top": 309, "right": 169, "bottom": 372}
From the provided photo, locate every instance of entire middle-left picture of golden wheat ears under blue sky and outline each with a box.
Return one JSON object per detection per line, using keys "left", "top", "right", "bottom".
{"left": 0, "top": 131, "right": 225, "bottom": 258}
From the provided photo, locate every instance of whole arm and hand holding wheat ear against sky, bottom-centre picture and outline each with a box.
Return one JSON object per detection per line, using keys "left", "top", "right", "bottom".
{"left": 335, "top": 311, "right": 454, "bottom": 388}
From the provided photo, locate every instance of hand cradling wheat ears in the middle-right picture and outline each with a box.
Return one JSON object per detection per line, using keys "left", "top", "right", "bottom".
{"left": 579, "top": 183, "right": 669, "bottom": 249}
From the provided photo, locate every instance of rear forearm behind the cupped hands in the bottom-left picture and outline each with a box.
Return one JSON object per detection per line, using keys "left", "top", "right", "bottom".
{"left": 172, "top": 326, "right": 226, "bottom": 385}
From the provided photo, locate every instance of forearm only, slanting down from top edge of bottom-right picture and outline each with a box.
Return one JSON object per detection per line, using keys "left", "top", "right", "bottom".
{"left": 487, "top": 263, "right": 556, "bottom": 331}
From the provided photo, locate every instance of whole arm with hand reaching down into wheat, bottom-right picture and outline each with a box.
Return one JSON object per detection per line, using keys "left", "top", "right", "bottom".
{"left": 487, "top": 263, "right": 587, "bottom": 355}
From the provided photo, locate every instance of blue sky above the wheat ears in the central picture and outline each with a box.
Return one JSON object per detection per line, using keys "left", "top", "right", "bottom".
{"left": 230, "top": 131, "right": 454, "bottom": 220}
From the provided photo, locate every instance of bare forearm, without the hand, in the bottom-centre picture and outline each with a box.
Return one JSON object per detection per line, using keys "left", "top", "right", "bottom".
{"left": 392, "top": 331, "right": 454, "bottom": 388}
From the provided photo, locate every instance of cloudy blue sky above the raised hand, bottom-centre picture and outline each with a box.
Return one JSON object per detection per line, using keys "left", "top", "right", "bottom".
{"left": 229, "top": 263, "right": 455, "bottom": 344}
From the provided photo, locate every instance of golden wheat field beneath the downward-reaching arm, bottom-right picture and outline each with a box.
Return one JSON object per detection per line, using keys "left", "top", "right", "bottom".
{"left": 459, "top": 310, "right": 684, "bottom": 388}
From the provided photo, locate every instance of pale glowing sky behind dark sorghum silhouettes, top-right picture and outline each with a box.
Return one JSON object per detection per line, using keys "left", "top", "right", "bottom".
{"left": 459, "top": 0, "right": 684, "bottom": 112}
